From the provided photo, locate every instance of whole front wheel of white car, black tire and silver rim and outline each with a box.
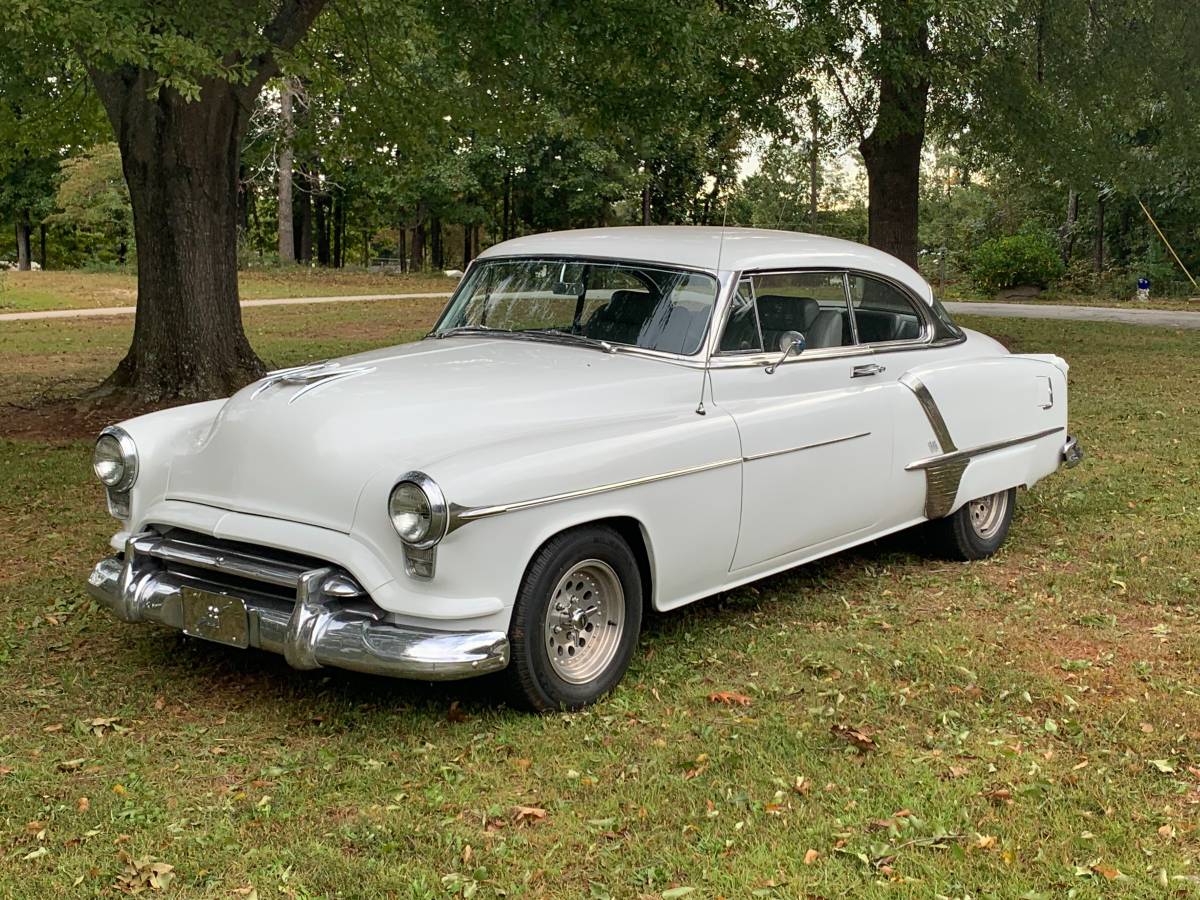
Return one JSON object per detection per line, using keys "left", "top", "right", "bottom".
{"left": 506, "top": 527, "right": 642, "bottom": 712}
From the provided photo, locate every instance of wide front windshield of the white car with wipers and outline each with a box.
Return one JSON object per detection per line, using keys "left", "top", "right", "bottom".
{"left": 432, "top": 258, "right": 718, "bottom": 355}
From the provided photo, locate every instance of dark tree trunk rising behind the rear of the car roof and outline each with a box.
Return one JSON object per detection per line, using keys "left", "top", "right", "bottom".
{"left": 858, "top": 13, "right": 930, "bottom": 269}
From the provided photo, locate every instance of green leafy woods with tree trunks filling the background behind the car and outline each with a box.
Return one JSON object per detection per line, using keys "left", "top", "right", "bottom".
{"left": 0, "top": 0, "right": 1200, "bottom": 400}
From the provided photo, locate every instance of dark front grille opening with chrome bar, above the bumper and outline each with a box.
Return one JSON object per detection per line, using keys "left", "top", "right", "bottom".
{"left": 146, "top": 526, "right": 343, "bottom": 602}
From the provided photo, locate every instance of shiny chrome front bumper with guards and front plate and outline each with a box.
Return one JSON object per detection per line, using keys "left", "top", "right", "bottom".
{"left": 88, "top": 532, "right": 509, "bottom": 680}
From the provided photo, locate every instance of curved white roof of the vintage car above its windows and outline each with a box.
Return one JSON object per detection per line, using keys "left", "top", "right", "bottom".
{"left": 479, "top": 226, "right": 932, "bottom": 302}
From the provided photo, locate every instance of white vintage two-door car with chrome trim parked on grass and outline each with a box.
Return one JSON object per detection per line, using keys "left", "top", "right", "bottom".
{"left": 90, "top": 227, "right": 1080, "bottom": 709}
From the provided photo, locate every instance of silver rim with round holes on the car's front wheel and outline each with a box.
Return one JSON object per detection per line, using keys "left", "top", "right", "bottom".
{"left": 545, "top": 559, "right": 625, "bottom": 684}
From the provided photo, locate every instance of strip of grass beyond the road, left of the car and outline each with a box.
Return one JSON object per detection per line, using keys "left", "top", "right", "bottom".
{"left": 0, "top": 268, "right": 458, "bottom": 312}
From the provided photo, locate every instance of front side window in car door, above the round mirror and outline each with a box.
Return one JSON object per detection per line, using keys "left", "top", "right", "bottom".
{"left": 754, "top": 272, "right": 854, "bottom": 352}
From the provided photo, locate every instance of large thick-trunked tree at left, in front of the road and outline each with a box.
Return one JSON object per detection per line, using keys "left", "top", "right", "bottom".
{"left": 6, "top": 0, "right": 325, "bottom": 401}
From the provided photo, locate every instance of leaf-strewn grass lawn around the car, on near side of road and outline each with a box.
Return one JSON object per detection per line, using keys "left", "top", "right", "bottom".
{"left": 0, "top": 301, "right": 1200, "bottom": 899}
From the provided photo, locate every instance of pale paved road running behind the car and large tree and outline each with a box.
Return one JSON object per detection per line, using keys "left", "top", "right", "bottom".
{"left": 0, "top": 292, "right": 1200, "bottom": 329}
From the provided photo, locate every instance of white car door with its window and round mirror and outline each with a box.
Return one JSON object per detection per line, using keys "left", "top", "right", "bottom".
{"left": 709, "top": 271, "right": 892, "bottom": 570}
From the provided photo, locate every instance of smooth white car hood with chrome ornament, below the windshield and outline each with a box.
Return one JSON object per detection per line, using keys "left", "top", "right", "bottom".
{"left": 167, "top": 337, "right": 702, "bottom": 532}
